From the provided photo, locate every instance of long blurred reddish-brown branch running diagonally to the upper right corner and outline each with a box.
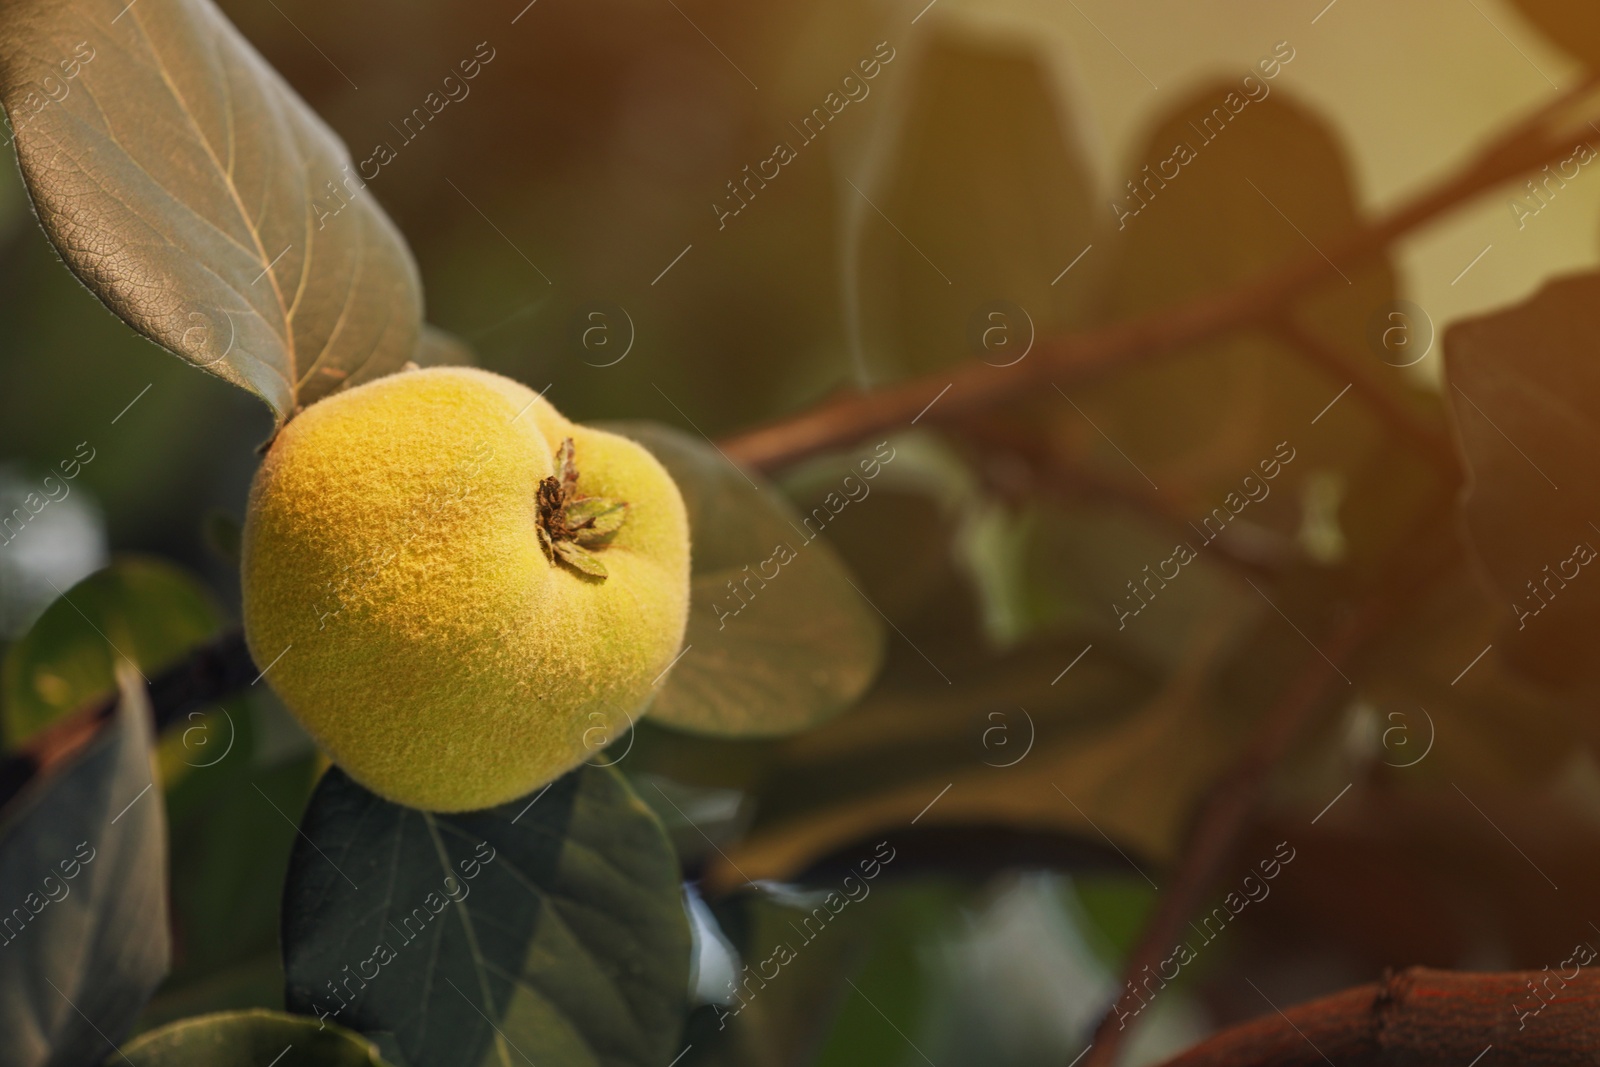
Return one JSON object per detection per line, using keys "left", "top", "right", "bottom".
{"left": 722, "top": 75, "right": 1597, "bottom": 469}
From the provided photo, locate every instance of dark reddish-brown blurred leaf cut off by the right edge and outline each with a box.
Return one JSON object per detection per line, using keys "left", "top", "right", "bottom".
{"left": 1445, "top": 274, "right": 1600, "bottom": 685}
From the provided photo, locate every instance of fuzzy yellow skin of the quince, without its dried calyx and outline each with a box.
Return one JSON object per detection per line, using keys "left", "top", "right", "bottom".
{"left": 243, "top": 368, "right": 690, "bottom": 811}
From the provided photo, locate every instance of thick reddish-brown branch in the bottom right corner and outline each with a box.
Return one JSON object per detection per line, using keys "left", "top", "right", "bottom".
{"left": 1162, "top": 963, "right": 1600, "bottom": 1067}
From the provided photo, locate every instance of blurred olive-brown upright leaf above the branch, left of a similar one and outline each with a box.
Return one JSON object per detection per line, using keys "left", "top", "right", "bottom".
{"left": 840, "top": 27, "right": 1106, "bottom": 374}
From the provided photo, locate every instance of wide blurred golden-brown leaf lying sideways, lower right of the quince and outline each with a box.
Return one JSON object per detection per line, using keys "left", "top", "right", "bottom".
{"left": 706, "top": 632, "right": 1228, "bottom": 891}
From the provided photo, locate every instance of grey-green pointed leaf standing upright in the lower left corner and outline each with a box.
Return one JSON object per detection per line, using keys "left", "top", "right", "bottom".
{"left": 0, "top": 665, "right": 170, "bottom": 1067}
